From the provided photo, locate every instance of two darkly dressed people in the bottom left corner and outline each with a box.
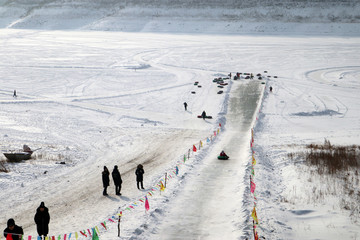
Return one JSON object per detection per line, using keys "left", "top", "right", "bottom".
{"left": 4, "top": 202, "right": 50, "bottom": 240}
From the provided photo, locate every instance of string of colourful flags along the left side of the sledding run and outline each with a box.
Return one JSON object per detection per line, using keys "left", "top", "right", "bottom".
{"left": 0, "top": 123, "right": 221, "bottom": 240}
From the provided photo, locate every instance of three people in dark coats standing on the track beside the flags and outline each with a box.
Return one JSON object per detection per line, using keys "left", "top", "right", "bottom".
{"left": 102, "top": 164, "right": 145, "bottom": 196}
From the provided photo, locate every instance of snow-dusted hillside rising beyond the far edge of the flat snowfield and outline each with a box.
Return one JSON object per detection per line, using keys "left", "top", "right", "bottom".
{"left": 0, "top": 0, "right": 360, "bottom": 35}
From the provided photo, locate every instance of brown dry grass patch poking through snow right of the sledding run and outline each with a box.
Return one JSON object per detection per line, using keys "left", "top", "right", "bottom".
{"left": 288, "top": 139, "right": 360, "bottom": 222}
